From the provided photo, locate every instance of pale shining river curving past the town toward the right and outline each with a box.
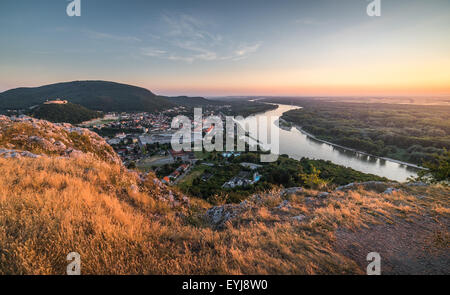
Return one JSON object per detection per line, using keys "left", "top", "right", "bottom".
{"left": 240, "top": 104, "right": 417, "bottom": 181}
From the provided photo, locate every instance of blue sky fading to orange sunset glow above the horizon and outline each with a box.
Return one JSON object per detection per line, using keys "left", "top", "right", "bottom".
{"left": 0, "top": 0, "right": 450, "bottom": 96}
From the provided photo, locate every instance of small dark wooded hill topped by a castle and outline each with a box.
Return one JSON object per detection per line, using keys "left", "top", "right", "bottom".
{"left": 29, "top": 102, "right": 103, "bottom": 124}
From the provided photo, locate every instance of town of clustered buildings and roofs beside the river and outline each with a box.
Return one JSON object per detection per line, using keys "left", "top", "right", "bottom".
{"left": 80, "top": 106, "right": 262, "bottom": 193}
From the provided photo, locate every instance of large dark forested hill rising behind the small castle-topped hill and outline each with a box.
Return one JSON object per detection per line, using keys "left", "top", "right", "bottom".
{"left": 0, "top": 81, "right": 174, "bottom": 112}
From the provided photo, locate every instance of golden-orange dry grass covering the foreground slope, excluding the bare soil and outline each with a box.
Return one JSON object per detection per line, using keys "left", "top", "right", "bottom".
{"left": 0, "top": 157, "right": 448, "bottom": 274}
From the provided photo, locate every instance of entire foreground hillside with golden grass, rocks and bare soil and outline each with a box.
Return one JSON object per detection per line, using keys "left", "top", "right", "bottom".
{"left": 0, "top": 116, "right": 450, "bottom": 274}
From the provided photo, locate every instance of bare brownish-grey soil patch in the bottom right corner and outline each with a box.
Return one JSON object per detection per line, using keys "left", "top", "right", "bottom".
{"left": 335, "top": 217, "right": 450, "bottom": 275}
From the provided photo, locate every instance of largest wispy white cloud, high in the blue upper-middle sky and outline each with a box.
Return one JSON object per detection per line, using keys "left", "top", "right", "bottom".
{"left": 141, "top": 14, "right": 261, "bottom": 63}
